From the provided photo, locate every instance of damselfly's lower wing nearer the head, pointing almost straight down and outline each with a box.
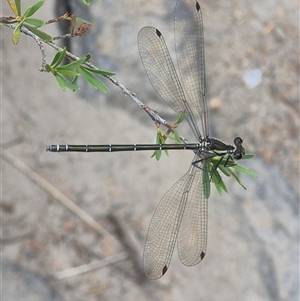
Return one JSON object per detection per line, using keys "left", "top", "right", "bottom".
{"left": 177, "top": 157, "right": 209, "bottom": 266}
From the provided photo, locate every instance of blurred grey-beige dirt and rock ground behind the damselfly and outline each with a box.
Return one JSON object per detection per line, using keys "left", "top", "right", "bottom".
{"left": 1, "top": 0, "right": 300, "bottom": 301}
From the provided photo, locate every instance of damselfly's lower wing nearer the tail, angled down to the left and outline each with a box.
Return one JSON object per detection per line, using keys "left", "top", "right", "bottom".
{"left": 143, "top": 165, "right": 202, "bottom": 279}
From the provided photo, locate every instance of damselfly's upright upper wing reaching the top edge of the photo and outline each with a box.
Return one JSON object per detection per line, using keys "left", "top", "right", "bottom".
{"left": 175, "top": 0, "right": 209, "bottom": 137}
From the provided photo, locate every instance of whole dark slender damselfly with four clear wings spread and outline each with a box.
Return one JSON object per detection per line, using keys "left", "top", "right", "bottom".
{"left": 46, "top": 0, "right": 245, "bottom": 279}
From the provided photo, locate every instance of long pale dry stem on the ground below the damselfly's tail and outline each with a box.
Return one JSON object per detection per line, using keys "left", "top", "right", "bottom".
{"left": 0, "top": 148, "right": 117, "bottom": 241}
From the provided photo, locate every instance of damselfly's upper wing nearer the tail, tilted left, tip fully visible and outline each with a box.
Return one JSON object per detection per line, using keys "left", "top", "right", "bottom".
{"left": 138, "top": 27, "right": 201, "bottom": 139}
